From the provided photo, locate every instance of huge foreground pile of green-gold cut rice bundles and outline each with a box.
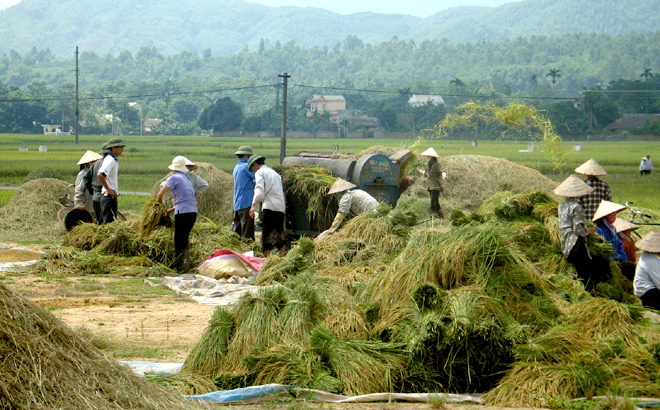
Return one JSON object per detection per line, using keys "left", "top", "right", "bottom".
{"left": 184, "top": 182, "right": 660, "bottom": 407}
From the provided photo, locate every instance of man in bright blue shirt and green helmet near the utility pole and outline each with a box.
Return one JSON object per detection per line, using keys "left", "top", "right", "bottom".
{"left": 232, "top": 145, "right": 254, "bottom": 240}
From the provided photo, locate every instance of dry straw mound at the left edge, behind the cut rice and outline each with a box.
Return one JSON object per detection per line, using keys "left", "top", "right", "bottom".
{"left": 0, "top": 178, "right": 73, "bottom": 241}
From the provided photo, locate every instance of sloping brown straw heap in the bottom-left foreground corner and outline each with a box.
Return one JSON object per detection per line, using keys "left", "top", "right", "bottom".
{"left": 0, "top": 283, "right": 214, "bottom": 410}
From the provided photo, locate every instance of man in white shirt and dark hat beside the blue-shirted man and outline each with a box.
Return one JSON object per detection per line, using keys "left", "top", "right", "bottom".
{"left": 248, "top": 154, "right": 286, "bottom": 257}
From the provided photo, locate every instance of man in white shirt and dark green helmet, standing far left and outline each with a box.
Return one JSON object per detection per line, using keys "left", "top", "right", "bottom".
{"left": 96, "top": 138, "right": 126, "bottom": 224}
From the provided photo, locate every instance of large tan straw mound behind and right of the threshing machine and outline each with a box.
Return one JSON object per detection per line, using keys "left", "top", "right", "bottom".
{"left": 403, "top": 155, "right": 558, "bottom": 215}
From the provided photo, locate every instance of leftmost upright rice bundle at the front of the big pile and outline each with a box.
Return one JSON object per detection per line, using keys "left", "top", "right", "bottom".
{"left": 182, "top": 306, "right": 236, "bottom": 379}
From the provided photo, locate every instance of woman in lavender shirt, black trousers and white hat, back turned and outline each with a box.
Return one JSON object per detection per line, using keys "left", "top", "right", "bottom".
{"left": 158, "top": 156, "right": 197, "bottom": 274}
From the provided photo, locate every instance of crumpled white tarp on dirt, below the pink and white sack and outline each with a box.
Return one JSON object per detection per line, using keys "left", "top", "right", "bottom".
{"left": 145, "top": 274, "right": 262, "bottom": 306}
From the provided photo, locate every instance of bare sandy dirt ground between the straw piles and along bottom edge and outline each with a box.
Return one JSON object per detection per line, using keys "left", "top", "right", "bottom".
{"left": 0, "top": 243, "right": 548, "bottom": 410}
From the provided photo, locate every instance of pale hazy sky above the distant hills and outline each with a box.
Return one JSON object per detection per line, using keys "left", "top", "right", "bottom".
{"left": 0, "top": 0, "right": 514, "bottom": 17}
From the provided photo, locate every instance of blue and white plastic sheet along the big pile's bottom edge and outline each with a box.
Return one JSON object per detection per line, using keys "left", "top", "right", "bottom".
{"left": 186, "top": 384, "right": 483, "bottom": 404}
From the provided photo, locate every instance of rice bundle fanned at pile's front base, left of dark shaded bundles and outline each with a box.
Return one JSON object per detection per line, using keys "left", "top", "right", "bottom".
{"left": 310, "top": 328, "right": 406, "bottom": 395}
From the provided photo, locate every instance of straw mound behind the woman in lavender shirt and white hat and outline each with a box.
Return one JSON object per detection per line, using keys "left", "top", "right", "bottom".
{"left": 151, "top": 162, "right": 234, "bottom": 225}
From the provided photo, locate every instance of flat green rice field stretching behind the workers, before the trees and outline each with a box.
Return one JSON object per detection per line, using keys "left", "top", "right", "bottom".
{"left": 0, "top": 134, "right": 660, "bottom": 210}
